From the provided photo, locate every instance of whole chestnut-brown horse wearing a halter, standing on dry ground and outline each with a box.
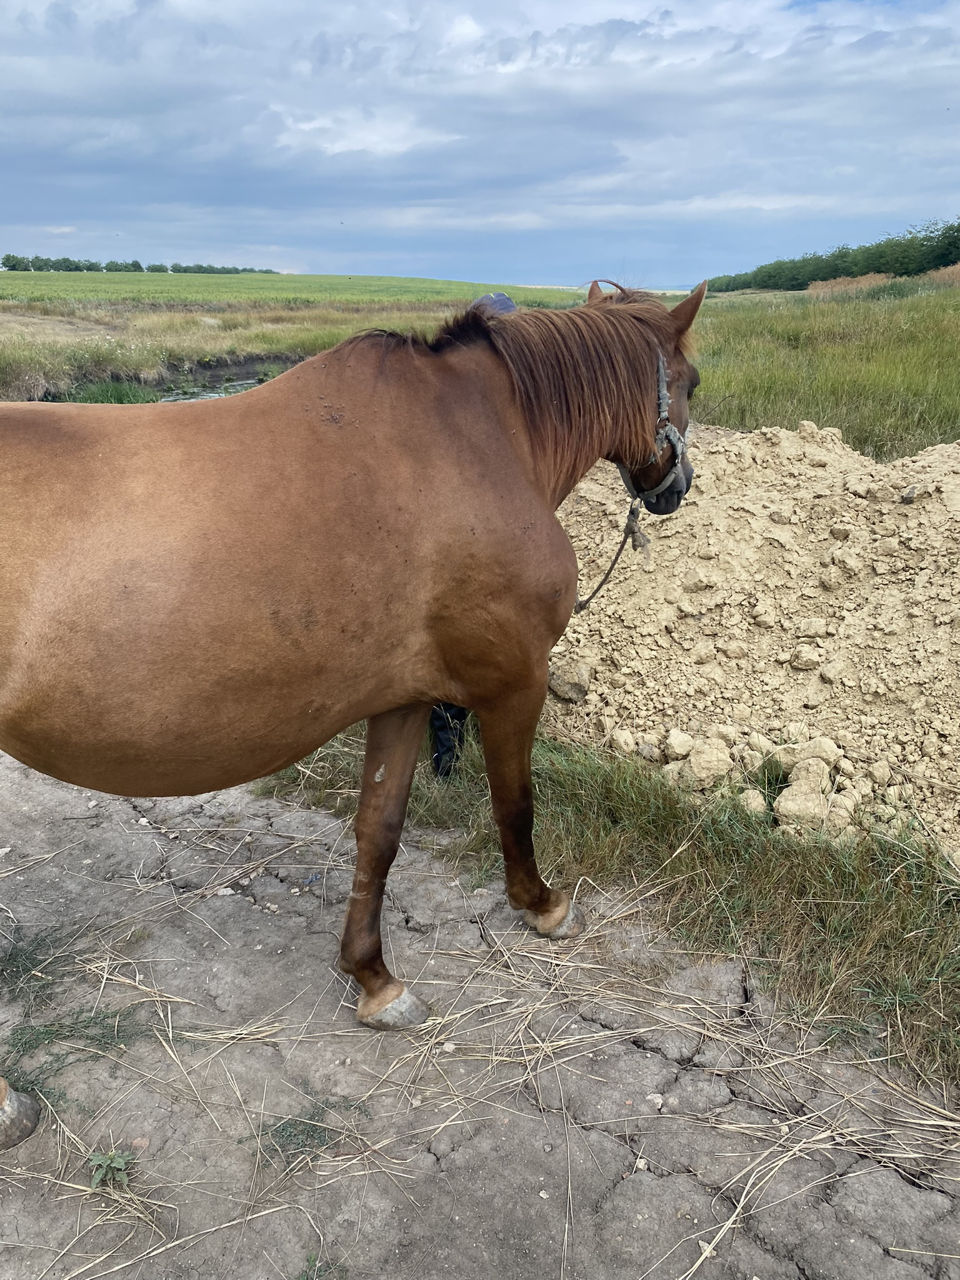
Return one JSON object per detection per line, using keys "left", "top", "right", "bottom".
{"left": 0, "top": 282, "right": 707, "bottom": 1144}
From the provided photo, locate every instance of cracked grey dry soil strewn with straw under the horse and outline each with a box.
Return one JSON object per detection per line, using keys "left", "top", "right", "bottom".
{"left": 0, "top": 758, "right": 960, "bottom": 1280}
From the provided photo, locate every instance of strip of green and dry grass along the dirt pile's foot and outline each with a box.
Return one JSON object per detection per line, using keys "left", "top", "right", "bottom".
{"left": 263, "top": 733, "right": 960, "bottom": 1084}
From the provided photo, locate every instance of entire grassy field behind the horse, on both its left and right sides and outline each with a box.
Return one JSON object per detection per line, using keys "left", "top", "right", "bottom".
{"left": 0, "top": 271, "right": 960, "bottom": 458}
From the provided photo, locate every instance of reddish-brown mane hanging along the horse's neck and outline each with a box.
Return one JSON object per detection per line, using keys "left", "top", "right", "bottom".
{"left": 355, "top": 289, "right": 682, "bottom": 474}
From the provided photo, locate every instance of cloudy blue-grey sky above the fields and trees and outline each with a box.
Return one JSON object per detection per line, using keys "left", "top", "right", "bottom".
{"left": 0, "top": 0, "right": 960, "bottom": 288}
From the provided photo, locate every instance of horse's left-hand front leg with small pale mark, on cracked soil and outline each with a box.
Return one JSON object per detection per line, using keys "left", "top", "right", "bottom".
{"left": 340, "top": 707, "right": 430, "bottom": 1029}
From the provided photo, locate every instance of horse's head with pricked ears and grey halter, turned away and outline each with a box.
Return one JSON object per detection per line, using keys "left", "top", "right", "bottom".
{"left": 588, "top": 280, "right": 707, "bottom": 516}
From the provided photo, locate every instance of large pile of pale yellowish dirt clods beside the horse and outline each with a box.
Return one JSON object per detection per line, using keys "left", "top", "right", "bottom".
{"left": 544, "top": 422, "right": 960, "bottom": 860}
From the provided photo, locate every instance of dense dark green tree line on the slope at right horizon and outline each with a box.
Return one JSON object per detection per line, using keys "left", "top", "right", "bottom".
{"left": 710, "top": 219, "right": 960, "bottom": 293}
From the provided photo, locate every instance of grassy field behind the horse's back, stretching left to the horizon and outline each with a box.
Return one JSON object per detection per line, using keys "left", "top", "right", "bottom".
{"left": 0, "top": 271, "right": 582, "bottom": 399}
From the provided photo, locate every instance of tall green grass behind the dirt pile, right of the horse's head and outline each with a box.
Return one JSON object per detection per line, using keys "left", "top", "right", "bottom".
{"left": 694, "top": 285, "right": 960, "bottom": 460}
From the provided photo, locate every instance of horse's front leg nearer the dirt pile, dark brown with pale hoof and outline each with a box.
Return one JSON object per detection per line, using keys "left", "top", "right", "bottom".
{"left": 477, "top": 682, "right": 584, "bottom": 938}
